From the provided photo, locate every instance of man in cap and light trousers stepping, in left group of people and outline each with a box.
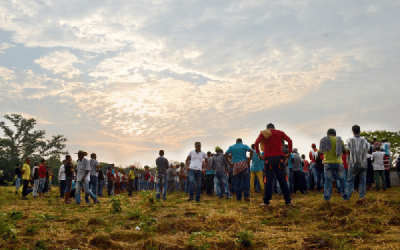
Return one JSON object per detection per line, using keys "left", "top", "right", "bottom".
{"left": 75, "top": 150, "right": 100, "bottom": 205}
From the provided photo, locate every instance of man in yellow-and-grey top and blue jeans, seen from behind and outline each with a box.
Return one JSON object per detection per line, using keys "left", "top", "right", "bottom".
{"left": 319, "top": 128, "right": 349, "bottom": 202}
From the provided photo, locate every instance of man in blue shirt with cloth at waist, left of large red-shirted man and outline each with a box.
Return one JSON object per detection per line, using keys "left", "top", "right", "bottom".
{"left": 225, "top": 138, "right": 254, "bottom": 201}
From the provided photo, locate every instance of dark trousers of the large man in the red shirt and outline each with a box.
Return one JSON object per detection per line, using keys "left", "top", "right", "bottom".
{"left": 264, "top": 156, "right": 292, "bottom": 204}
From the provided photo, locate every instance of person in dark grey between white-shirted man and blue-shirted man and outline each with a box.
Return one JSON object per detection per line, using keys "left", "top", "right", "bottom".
{"left": 211, "top": 147, "right": 230, "bottom": 199}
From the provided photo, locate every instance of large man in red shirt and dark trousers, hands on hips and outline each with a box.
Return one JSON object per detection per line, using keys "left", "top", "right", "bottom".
{"left": 255, "top": 123, "right": 293, "bottom": 207}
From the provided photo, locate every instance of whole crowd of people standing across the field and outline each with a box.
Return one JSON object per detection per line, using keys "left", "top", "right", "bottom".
{"left": 10, "top": 124, "right": 400, "bottom": 207}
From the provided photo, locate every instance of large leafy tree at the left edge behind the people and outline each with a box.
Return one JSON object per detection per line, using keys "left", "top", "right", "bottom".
{"left": 0, "top": 114, "right": 68, "bottom": 183}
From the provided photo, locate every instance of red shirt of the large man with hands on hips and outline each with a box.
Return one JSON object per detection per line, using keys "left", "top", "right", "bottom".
{"left": 255, "top": 129, "right": 293, "bottom": 157}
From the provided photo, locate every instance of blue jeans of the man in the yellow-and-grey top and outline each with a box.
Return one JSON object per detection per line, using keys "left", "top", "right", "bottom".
{"left": 324, "top": 164, "right": 349, "bottom": 201}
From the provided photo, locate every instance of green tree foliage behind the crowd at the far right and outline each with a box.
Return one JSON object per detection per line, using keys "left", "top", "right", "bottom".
{"left": 360, "top": 130, "right": 400, "bottom": 165}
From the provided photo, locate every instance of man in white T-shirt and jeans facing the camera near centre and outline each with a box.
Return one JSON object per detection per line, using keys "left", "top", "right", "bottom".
{"left": 186, "top": 142, "right": 208, "bottom": 202}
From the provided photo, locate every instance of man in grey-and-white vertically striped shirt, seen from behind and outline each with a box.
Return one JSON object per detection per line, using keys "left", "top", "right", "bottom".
{"left": 347, "top": 125, "right": 370, "bottom": 199}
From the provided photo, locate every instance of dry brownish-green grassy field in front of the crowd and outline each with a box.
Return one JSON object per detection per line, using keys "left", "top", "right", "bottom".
{"left": 0, "top": 187, "right": 400, "bottom": 249}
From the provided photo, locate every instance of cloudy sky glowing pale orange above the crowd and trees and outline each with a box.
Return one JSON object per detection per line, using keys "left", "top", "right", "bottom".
{"left": 0, "top": 0, "right": 400, "bottom": 166}
